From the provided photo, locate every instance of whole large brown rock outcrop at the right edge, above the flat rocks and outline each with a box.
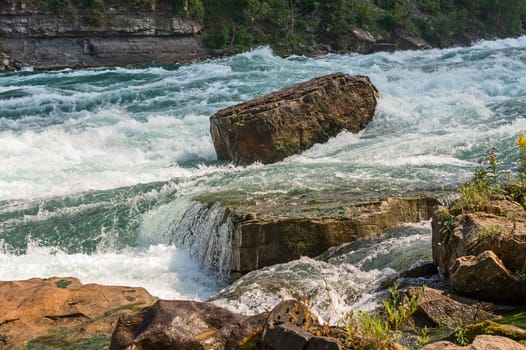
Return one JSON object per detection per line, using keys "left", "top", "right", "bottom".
{"left": 432, "top": 196, "right": 526, "bottom": 302}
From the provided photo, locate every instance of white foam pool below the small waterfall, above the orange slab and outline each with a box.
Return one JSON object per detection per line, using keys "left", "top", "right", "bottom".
{"left": 0, "top": 243, "right": 222, "bottom": 300}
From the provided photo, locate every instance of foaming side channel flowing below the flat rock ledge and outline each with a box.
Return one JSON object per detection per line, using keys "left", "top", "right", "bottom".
{"left": 212, "top": 222, "right": 431, "bottom": 324}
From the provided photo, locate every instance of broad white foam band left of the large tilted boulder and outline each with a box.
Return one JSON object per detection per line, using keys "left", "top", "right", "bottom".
{"left": 0, "top": 109, "right": 221, "bottom": 199}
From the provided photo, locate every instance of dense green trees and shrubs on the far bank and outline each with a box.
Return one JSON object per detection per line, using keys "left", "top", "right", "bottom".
{"left": 23, "top": 0, "right": 526, "bottom": 54}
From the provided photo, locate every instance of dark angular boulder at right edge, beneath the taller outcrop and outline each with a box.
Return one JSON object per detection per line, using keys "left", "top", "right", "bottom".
{"left": 449, "top": 250, "right": 526, "bottom": 303}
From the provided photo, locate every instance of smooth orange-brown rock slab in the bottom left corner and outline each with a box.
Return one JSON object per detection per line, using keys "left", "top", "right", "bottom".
{"left": 0, "top": 277, "right": 155, "bottom": 349}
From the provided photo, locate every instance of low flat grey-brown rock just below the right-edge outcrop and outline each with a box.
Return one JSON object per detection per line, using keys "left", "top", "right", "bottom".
{"left": 406, "top": 287, "right": 498, "bottom": 327}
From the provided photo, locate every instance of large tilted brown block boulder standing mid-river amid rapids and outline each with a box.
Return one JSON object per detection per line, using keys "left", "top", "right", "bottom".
{"left": 210, "top": 73, "right": 377, "bottom": 165}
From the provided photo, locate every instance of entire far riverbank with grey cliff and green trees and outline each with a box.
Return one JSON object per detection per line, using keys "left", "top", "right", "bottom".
{"left": 0, "top": 0, "right": 526, "bottom": 71}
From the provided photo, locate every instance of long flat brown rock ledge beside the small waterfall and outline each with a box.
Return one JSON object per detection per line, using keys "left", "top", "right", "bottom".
{"left": 227, "top": 197, "right": 436, "bottom": 274}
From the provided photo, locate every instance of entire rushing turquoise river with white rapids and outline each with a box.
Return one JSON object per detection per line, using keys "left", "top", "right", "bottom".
{"left": 0, "top": 37, "right": 526, "bottom": 317}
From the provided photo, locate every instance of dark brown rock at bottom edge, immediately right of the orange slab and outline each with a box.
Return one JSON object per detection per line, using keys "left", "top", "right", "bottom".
{"left": 110, "top": 300, "right": 265, "bottom": 350}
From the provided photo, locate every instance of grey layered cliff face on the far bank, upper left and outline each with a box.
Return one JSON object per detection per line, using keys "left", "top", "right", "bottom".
{"left": 0, "top": 1, "right": 207, "bottom": 69}
